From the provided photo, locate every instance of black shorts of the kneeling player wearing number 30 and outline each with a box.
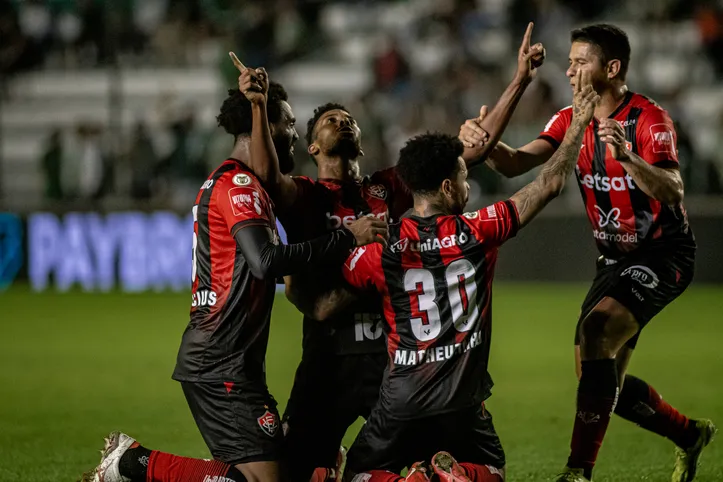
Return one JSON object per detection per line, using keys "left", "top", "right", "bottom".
{"left": 346, "top": 404, "right": 505, "bottom": 475}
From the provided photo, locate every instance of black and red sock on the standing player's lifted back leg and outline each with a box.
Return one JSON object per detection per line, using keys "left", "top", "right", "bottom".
{"left": 615, "top": 375, "right": 699, "bottom": 448}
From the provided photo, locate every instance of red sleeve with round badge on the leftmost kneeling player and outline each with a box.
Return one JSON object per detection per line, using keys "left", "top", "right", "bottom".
{"left": 213, "top": 172, "right": 273, "bottom": 234}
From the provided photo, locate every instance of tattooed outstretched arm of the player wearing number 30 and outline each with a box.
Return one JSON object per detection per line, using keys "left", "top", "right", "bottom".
{"left": 510, "top": 71, "right": 600, "bottom": 227}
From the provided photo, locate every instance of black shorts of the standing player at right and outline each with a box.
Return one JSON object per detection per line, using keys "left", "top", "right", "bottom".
{"left": 575, "top": 244, "right": 695, "bottom": 348}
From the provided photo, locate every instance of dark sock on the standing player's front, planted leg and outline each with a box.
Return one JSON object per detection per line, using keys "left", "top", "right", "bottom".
{"left": 567, "top": 359, "right": 618, "bottom": 479}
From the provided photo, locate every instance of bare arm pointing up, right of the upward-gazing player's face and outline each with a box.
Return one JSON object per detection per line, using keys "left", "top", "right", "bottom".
{"left": 462, "top": 22, "right": 545, "bottom": 167}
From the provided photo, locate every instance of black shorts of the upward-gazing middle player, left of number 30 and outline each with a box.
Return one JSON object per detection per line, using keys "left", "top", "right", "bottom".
{"left": 283, "top": 350, "right": 388, "bottom": 482}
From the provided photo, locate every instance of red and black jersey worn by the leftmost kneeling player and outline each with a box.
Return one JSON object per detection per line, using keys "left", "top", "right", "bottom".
{"left": 173, "top": 159, "right": 278, "bottom": 382}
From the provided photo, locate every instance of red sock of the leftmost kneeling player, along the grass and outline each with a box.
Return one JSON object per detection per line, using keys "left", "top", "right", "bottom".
{"left": 146, "top": 450, "right": 240, "bottom": 482}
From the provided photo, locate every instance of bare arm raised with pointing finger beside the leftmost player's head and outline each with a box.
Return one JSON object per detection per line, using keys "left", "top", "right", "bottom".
{"left": 229, "top": 52, "right": 298, "bottom": 210}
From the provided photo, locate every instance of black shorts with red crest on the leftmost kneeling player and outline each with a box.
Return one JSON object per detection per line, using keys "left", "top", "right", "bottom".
{"left": 181, "top": 382, "right": 284, "bottom": 465}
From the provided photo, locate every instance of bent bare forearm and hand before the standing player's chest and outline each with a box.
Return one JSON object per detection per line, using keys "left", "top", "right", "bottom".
{"left": 598, "top": 119, "right": 683, "bottom": 205}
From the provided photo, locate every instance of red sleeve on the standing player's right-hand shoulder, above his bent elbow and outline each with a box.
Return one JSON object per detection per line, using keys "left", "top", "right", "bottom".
{"left": 635, "top": 106, "right": 678, "bottom": 167}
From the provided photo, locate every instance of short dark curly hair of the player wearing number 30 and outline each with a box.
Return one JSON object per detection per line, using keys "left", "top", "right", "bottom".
{"left": 397, "top": 132, "right": 464, "bottom": 195}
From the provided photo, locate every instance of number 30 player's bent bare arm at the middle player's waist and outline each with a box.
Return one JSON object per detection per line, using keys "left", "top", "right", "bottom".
{"left": 284, "top": 274, "right": 357, "bottom": 321}
